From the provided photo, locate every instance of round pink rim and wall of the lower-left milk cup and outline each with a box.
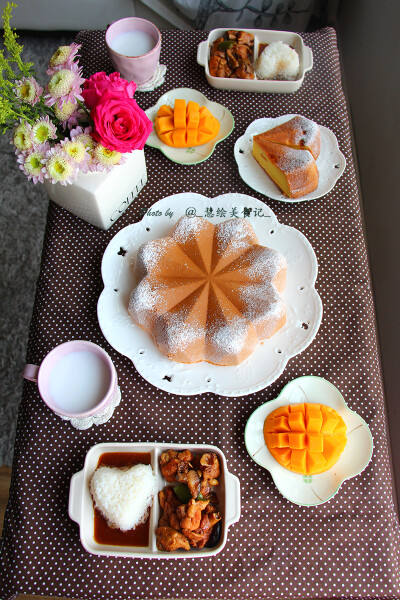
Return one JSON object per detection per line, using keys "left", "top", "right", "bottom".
{"left": 37, "top": 340, "right": 118, "bottom": 419}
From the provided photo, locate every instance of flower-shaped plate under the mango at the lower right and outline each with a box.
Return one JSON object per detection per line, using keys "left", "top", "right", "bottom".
{"left": 244, "top": 376, "right": 373, "bottom": 506}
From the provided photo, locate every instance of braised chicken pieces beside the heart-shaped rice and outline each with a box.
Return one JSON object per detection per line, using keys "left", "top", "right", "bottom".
{"left": 156, "top": 450, "right": 221, "bottom": 552}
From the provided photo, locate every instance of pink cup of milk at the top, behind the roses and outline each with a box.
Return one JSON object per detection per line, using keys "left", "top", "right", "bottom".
{"left": 106, "top": 17, "right": 161, "bottom": 84}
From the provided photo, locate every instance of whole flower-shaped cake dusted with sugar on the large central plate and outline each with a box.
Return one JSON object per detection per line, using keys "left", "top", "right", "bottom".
{"left": 128, "top": 217, "right": 286, "bottom": 366}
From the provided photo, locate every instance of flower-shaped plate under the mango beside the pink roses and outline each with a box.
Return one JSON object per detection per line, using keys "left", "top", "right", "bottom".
{"left": 145, "top": 88, "right": 235, "bottom": 165}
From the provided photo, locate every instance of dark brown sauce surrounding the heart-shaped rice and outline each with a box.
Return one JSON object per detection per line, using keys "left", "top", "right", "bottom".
{"left": 94, "top": 452, "right": 151, "bottom": 547}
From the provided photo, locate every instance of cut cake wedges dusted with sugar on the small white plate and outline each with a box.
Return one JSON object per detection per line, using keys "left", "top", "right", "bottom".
{"left": 253, "top": 116, "right": 321, "bottom": 198}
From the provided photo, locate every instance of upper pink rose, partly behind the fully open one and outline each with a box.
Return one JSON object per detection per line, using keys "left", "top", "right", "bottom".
{"left": 82, "top": 71, "right": 136, "bottom": 110}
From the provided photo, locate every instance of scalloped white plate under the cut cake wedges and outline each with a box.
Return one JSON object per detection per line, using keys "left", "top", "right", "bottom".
{"left": 234, "top": 115, "right": 346, "bottom": 202}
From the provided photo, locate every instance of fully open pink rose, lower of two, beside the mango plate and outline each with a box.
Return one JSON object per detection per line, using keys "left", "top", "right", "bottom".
{"left": 90, "top": 98, "right": 153, "bottom": 152}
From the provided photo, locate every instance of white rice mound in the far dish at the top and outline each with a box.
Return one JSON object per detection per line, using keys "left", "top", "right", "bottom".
{"left": 255, "top": 41, "right": 300, "bottom": 80}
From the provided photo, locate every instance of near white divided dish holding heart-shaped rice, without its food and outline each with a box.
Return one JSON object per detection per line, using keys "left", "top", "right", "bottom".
{"left": 68, "top": 443, "right": 240, "bottom": 559}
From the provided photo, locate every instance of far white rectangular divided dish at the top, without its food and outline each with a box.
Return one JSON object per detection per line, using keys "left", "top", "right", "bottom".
{"left": 197, "top": 28, "right": 313, "bottom": 94}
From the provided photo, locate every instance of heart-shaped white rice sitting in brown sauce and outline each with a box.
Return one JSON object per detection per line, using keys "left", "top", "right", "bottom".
{"left": 90, "top": 465, "right": 157, "bottom": 531}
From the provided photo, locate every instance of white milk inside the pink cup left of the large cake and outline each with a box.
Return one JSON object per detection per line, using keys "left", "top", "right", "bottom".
{"left": 49, "top": 350, "right": 110, "bottom": 413}
